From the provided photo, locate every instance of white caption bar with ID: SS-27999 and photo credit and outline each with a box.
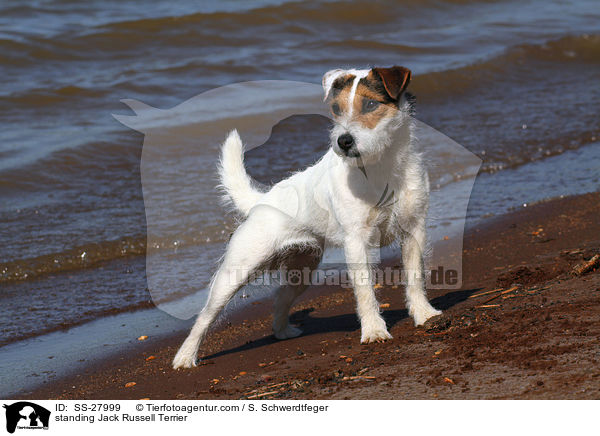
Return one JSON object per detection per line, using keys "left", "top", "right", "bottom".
{"left": 0, "top": 400, "right": 598, "bottom": 436}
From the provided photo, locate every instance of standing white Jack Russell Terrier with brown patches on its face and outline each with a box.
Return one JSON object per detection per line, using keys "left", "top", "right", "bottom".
{"left": 173, "top": 67, "right": 441, "bottom": 368}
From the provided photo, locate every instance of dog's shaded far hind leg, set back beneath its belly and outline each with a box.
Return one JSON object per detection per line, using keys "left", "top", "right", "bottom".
{"left": 273, "top": 250, "right": 322, "bottom": 339}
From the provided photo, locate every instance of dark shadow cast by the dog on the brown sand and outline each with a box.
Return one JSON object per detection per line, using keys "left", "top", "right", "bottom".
{"left": 202, "top": 288, "right": 483, "bottom": 360}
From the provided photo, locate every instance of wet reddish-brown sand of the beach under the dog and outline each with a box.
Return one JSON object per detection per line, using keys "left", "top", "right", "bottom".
{"left": 17, "top": 193, "right": 600, "bottom": 399}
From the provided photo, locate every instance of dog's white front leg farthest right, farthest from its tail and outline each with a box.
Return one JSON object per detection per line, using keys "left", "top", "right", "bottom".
{"left": 402, "top": 219, "right": 442, "bottom": 325}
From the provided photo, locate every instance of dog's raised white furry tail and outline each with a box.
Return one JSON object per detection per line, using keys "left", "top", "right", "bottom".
{"left": 218, "top": 129, "right": 263, "bottom": 216}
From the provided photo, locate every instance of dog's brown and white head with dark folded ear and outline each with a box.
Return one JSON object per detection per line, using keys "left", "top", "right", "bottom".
{"left": 323, "top": 66, "right": 411, "bottom": 163}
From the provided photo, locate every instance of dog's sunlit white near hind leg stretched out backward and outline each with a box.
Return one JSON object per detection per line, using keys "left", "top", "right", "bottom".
{"left": 173, "top": 206, "right": 301, "bottom": 368}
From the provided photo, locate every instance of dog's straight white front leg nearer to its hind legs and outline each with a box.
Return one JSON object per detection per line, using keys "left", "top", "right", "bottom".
{"left": 344, "top": 236, "right": 392, "bottom": 343}
